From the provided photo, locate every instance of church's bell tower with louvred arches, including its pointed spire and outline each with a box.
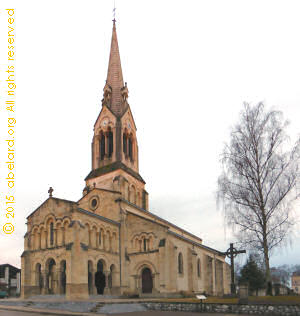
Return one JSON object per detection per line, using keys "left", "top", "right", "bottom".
{"left": 84, "top": 20, "right": 148, "bottom": 209}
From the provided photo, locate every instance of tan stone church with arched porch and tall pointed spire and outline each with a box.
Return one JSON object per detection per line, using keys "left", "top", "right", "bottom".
{"left": 21, "top": 20, "right": 230, "bottom": 299}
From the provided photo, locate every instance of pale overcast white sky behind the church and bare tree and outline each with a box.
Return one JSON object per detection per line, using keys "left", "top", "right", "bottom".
{"left": 0, "top": 0, "right": 300, "bottom": 266}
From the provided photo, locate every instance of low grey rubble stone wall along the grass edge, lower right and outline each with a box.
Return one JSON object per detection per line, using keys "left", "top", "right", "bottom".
{"left": 143, "top": 302, "right": 300, "bottom": 316}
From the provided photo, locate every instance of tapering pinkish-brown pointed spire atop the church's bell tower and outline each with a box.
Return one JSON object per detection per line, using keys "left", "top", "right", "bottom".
{"left": 103, "top": 20, "right": 128, "bottom": 115}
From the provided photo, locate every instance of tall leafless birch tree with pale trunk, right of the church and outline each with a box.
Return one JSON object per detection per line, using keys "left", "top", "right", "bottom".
{"left": 218, "top": 103, "right": 300, "bottom": 293}
